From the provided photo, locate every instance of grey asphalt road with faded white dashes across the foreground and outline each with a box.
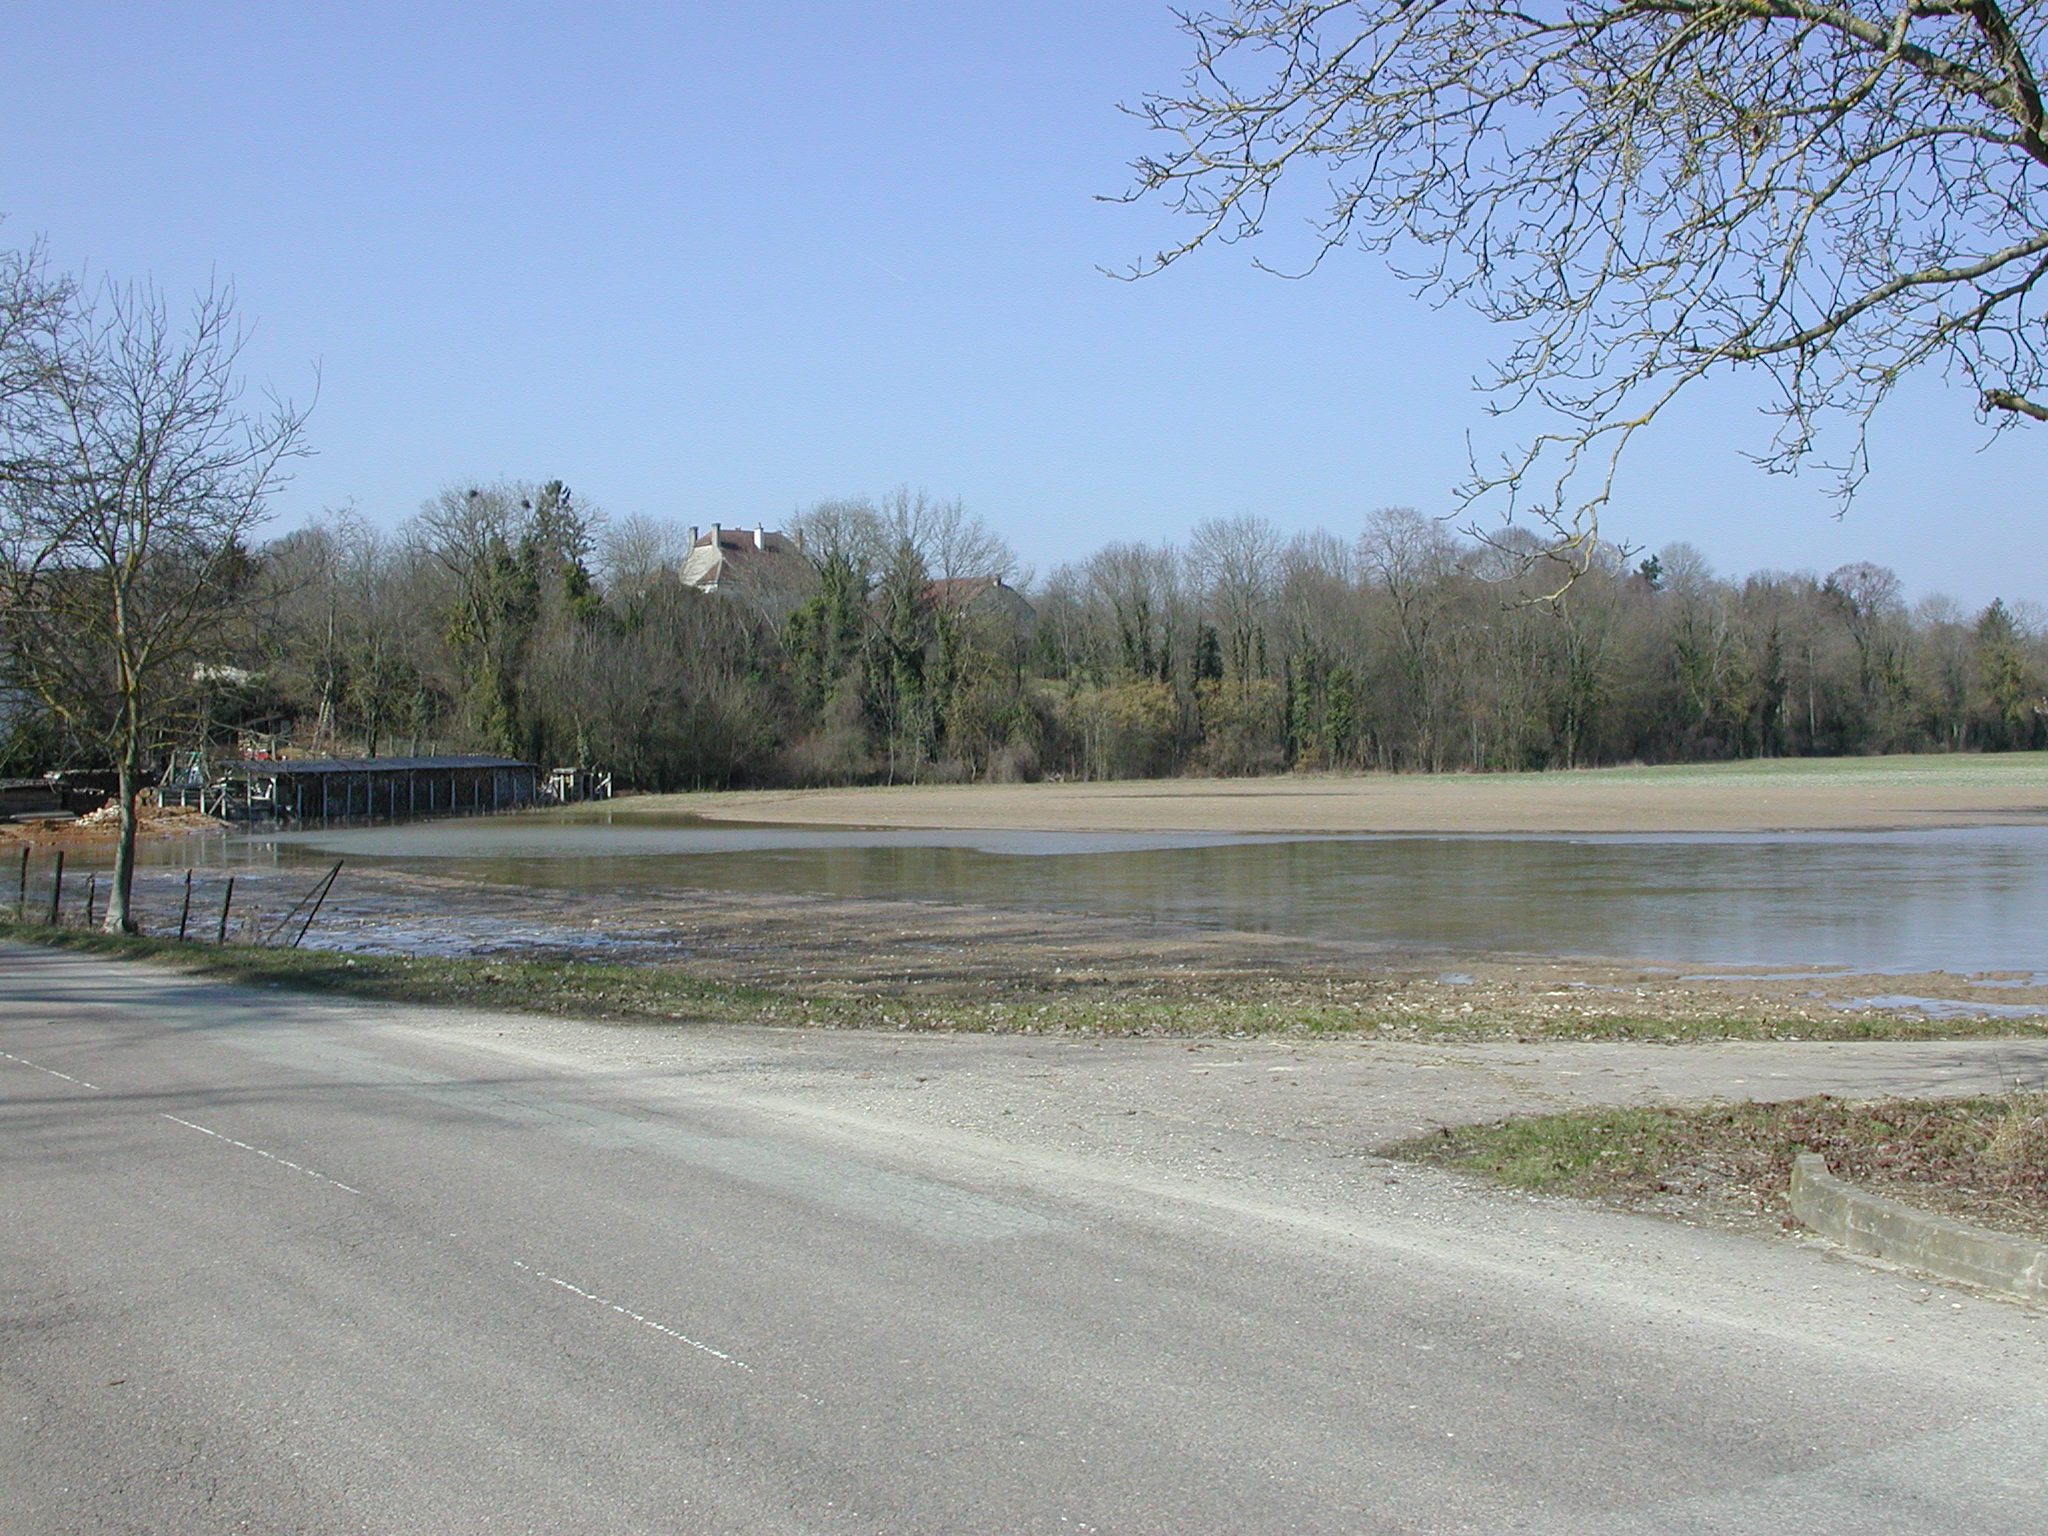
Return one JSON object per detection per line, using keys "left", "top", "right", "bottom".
{"left": 0, "top": 946, "right": 2048, "bottom": 1536}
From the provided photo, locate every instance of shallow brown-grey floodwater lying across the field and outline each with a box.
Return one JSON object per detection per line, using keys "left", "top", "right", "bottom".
{"left": 128, "top": 811, "right": 2048, "bottom": 973}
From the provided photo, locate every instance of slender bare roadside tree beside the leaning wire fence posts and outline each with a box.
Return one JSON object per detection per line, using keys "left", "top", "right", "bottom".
{"left": 0, "top": 287, "right": 305, "bottom": 932}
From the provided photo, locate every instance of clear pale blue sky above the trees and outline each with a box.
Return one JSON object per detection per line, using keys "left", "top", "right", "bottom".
{"left": 0, "top": 0, "right": 2048, "bottom": 606}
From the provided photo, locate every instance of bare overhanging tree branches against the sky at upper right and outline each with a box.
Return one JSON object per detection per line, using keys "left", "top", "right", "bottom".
{"left": 1130, "top": 0, "right": 2048, "bottom": 571}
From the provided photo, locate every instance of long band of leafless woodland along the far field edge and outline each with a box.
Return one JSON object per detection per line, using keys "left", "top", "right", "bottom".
{"left": 4, "top": 481, "right": 2048, "bottom": 791}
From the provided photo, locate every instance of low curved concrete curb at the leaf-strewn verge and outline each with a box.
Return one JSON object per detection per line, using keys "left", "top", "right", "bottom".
{"left": 1792, "top": 1153, "right": 2048, "bottom": 1307}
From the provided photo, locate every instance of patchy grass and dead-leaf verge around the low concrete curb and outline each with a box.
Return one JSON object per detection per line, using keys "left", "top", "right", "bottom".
{"left": 1380, "top": 1092, "right": 2048, "bottom": 1241}
